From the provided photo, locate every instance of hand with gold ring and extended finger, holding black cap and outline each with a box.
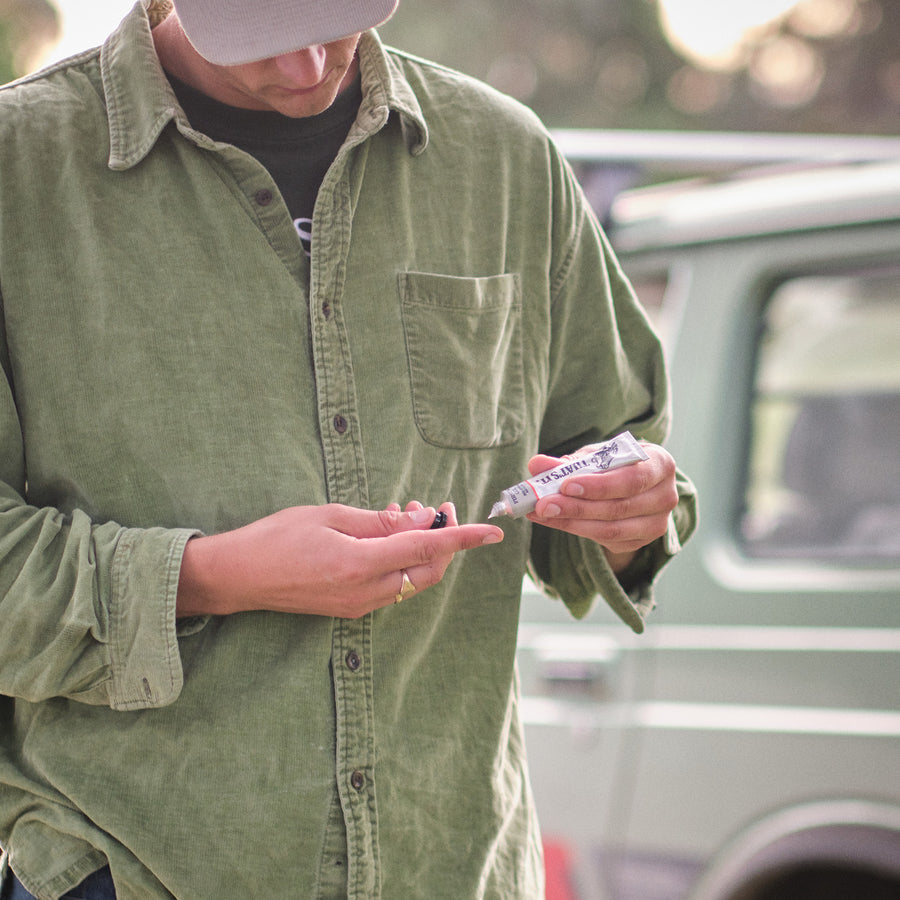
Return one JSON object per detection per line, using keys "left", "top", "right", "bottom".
{"left": 177, "top": 503, "right": 503, "bottom": 619}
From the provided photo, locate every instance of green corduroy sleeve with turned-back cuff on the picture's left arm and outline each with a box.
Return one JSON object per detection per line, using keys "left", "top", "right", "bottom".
{"left": 0, "top": 488, "right": 202, "bottom": 710}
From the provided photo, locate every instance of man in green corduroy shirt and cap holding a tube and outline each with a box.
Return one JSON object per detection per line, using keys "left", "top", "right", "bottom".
{"left": 0, "top": 0, "right": 694, "bottom": 900}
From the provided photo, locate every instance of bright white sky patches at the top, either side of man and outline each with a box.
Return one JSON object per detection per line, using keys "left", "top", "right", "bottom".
{"left": 47, "top": 0, "right": 797, "bottom": 64}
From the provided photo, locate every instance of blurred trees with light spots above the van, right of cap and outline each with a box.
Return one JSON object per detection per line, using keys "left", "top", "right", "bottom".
{"left": 381, "top": 0, "right": 900, "bottom": 134}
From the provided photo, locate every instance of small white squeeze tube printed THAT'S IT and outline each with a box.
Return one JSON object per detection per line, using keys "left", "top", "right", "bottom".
{"left": 488, "top": 431, "right": 650, "bottom": 519}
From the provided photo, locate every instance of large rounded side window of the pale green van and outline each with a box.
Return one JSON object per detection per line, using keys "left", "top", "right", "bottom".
{"left": 740, "top": 267, "right": 900, "bottom": 561}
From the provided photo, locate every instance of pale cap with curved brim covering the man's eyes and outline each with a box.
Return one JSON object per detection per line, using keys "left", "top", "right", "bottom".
{"left": 173, "top": 0, "right": 399, "bottom": 66}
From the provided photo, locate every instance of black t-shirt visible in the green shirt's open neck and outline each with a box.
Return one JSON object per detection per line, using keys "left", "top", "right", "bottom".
{"left": 168, "top": 75, "right": 362, "bottom": 255}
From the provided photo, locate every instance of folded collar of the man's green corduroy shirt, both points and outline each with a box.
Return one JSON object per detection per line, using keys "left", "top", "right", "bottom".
{"left": 100, "top": 3, "right": 428, "bottom": 170}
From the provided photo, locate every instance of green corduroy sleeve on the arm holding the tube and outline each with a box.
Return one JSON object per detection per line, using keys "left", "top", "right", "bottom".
{"left": 529, "top": 148, "right": 697, "bottom": 632}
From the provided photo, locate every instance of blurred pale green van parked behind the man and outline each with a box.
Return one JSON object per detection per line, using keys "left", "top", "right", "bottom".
{"left": 518, "top": 135, "right": 900, "bottom": 900}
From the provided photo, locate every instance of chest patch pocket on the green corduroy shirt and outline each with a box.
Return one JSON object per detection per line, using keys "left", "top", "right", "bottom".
{"left": 399, "top": 272, "right": 525, "bottom": 448}
